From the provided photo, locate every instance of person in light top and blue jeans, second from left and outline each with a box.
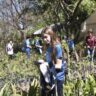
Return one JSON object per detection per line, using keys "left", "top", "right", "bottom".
{"left": 25, "top": 36, "right": 31, "bottom": 59}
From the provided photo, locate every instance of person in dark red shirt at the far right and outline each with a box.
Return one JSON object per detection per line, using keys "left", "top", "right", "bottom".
{"left": 85, "top": 29, "right": 96, "bottom": 62}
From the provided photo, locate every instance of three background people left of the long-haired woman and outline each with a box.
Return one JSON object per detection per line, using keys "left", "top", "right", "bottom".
{"left": 6, "top": 35, "right": 42, "bottom": 59}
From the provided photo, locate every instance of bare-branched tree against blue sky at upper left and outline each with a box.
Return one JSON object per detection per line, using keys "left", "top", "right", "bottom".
{"left": 0, "top": 0, "right": 39, "bottom": 39}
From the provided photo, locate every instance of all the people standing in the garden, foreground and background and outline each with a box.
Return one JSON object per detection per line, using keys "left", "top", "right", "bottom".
{"left": 6, "top": 27, "right": 96, "bottom": 96}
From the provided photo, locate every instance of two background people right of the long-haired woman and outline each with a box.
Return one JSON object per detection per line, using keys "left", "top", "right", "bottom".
{"left": 61, "top": 29, "right": 96, "bottom": 62}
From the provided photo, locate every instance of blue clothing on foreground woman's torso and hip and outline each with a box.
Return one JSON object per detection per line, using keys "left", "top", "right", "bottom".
{"left": 46, "top": 44, "right": 64, "bottom": 80}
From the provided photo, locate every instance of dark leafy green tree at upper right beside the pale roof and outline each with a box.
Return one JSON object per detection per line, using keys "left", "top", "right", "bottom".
{"left": 39, "top": 0, "right": 96, "bottom": 38}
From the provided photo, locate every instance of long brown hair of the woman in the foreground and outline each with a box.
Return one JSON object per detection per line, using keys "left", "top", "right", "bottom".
{"left": 41, "top": 27, "right": 60, "bottom": 63}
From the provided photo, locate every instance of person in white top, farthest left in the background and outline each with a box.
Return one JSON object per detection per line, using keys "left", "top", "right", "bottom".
{"left": 6, "top": 40, "right": 14, "bottom": 59}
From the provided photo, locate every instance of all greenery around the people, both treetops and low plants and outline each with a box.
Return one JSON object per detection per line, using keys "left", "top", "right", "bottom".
{"left": 0, "top": 0, "right": 96, "bottom": 96}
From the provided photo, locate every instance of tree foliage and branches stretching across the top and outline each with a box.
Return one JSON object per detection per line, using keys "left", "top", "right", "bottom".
{"left": 0, "top": 0, "right": 96, "bottom": 39}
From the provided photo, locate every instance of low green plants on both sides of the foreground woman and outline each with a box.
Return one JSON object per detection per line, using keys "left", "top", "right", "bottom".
{"left": 0, "top": 47, "right": 96, "bottom": 96}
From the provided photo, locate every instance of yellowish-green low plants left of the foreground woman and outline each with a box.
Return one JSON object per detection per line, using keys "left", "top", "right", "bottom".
{"left": 0, "top": 48, "right": 40, "bottom": 86}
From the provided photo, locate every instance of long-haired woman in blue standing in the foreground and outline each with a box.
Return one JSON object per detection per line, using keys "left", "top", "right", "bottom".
{"left": 41, "top": 27, "right": 64, "bottom": 96}
